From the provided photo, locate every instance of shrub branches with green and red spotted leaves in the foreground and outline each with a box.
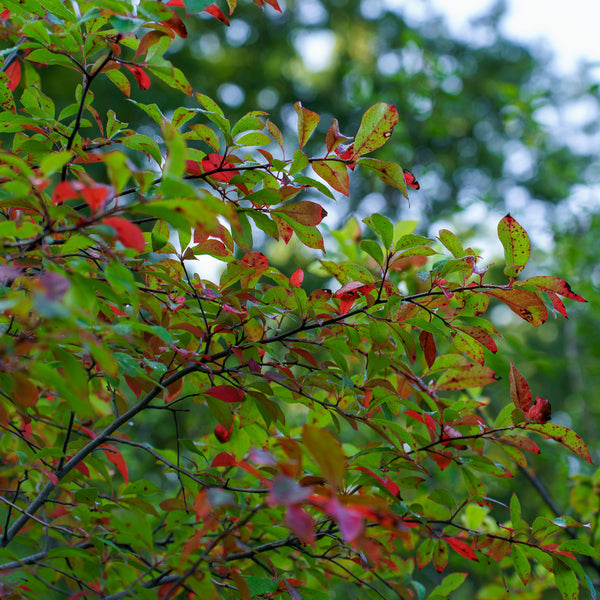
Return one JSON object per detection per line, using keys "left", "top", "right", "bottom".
{"left": 0, "top": 0, "right": 599, "bottom": 600}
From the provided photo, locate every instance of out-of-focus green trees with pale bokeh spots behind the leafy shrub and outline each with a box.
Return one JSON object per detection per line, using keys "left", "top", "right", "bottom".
{"left": 44, "top": 0, "right": 600, "bottom": 598}
